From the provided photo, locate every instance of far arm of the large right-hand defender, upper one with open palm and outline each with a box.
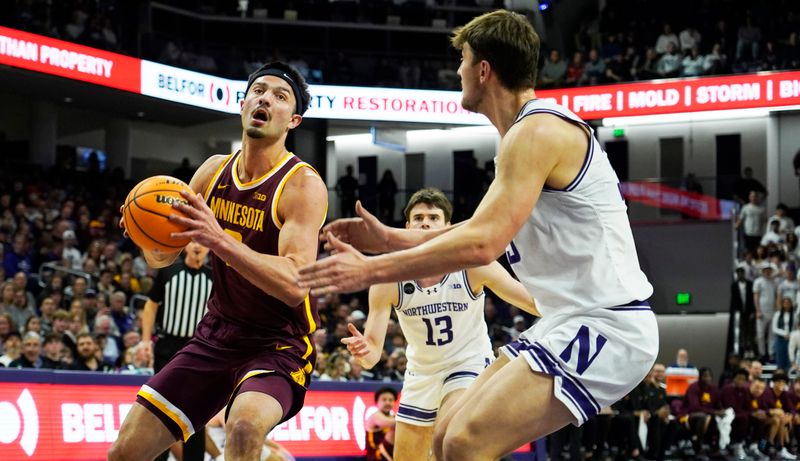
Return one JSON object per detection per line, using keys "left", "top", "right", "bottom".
{"left": 319, "top": 200, "right": 460, "bottom": 254}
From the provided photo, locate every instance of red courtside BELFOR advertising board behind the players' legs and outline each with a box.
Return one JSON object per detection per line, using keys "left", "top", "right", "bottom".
{"left": 0, "top": 376, "right": 530, "bottom": 461}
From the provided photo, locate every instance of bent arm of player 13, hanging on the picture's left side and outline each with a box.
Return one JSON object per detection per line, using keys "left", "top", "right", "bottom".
{"left": 342, "top": 283, "right": 399, "bottom": 369}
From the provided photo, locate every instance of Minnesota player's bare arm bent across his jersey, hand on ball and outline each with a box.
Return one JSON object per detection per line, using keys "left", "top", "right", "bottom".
{"left": 170, "top": 168, "right": 328, "bottom": 306}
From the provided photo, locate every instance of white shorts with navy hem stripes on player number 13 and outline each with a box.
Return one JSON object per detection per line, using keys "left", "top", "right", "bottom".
{"left": 396, "top": 354, "right": 493, "bottom": 426}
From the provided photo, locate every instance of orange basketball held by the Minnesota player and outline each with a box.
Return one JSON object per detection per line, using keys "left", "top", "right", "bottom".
{"left": 122, "top": 176, "right": 192, "bottom": 253}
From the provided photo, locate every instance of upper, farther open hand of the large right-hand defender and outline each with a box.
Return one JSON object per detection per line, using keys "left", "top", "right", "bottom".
{"left": 320, "top": 200, "right": 390, "bottom": 253}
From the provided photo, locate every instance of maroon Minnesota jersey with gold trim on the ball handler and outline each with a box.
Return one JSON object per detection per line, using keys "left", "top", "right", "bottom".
{"left": 205, "top": 151, "right": 321, "bottom": 338}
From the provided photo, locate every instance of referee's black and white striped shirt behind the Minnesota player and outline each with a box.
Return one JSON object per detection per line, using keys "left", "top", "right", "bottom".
{"left": 150, "top": 261, "right": 212, "bottom": 338}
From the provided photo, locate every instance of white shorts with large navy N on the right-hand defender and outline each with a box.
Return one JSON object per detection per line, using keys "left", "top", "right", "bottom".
{"left": 500, "top": 301, "right": 658, "bottom": 426}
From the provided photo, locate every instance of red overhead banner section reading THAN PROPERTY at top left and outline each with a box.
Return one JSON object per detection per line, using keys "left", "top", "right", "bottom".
{"left": 0, "top": 27, "right": 141, "bottom": 93}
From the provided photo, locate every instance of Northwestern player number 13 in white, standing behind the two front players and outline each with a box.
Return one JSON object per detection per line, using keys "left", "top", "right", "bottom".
{"left": 342, "top": 189, "right": 538, "bottom": 461}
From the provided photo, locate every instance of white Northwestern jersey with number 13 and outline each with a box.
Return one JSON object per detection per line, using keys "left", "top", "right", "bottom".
{"left": 394, "top": 271, "right": 494, "bottom": 374}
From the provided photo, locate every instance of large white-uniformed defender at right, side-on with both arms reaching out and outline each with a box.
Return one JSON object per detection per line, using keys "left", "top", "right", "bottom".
{"left": 298, "top": 10, "right": 658, "bottom": 461}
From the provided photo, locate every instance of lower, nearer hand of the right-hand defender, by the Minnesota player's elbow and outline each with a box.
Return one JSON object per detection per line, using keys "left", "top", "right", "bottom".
{"left": 297, "top": 233, "right": 372, "bottom": 296}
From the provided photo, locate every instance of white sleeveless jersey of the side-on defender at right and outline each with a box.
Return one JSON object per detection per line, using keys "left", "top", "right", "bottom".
{"left": 507, "top": 99, "right": 653, "bottom": 316}
